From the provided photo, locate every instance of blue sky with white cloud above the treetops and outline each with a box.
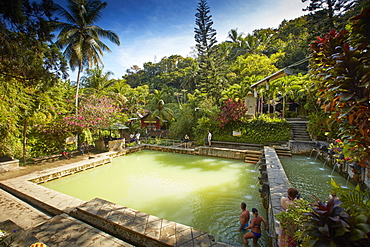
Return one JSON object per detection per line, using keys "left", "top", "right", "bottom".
{"left": 54, "top": 0, "right": 306, "bottom": 80}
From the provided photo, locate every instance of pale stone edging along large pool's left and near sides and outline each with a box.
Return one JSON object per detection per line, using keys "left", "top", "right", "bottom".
{"left": 0, "top": 145, "right": 230, "bottom": 246}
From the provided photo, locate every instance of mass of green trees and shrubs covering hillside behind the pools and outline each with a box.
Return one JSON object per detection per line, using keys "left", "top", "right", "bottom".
{"left": 0, "top": 0, "right": 368, "bottom": 164}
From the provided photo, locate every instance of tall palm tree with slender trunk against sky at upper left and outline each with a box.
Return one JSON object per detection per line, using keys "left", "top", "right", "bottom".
{"left": 55, "top": 0, "right": 120, "bottom": 110}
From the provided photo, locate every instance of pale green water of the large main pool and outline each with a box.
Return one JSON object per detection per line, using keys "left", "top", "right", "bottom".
{"left": 42, "top": 150, "right": 268, "bottom": 246}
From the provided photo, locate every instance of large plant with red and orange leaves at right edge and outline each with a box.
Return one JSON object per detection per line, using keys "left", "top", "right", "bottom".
{"left": 310, "top": 8, "right": 370, "bottom": 167}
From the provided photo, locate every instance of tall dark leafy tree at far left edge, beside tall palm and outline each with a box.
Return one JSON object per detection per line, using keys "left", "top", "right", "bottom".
{"left": 0, "top": 0, "right": 66, "bottom": 162}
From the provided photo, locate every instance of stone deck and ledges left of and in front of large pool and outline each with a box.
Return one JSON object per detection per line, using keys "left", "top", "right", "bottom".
{"left": 0, "top": 151, "right": 229, "bottom": 246}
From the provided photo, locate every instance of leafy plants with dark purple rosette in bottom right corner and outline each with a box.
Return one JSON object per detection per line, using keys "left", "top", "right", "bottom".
{"left": 275, "top": 180, "right": 370, "bottom": 247}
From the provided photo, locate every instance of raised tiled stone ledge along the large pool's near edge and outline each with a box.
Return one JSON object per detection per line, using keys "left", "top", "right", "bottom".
{"left": 70, "top": 198, "right": 229, "bottom": 246}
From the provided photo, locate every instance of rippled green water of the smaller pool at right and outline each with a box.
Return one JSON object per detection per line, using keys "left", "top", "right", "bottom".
{"left": 280, "top": 155, "right": 354, "bottom": 201}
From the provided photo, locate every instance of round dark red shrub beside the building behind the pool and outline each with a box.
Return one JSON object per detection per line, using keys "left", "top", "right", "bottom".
{"left": 216, "top": 98, "right": 248, "bottom": 128}
